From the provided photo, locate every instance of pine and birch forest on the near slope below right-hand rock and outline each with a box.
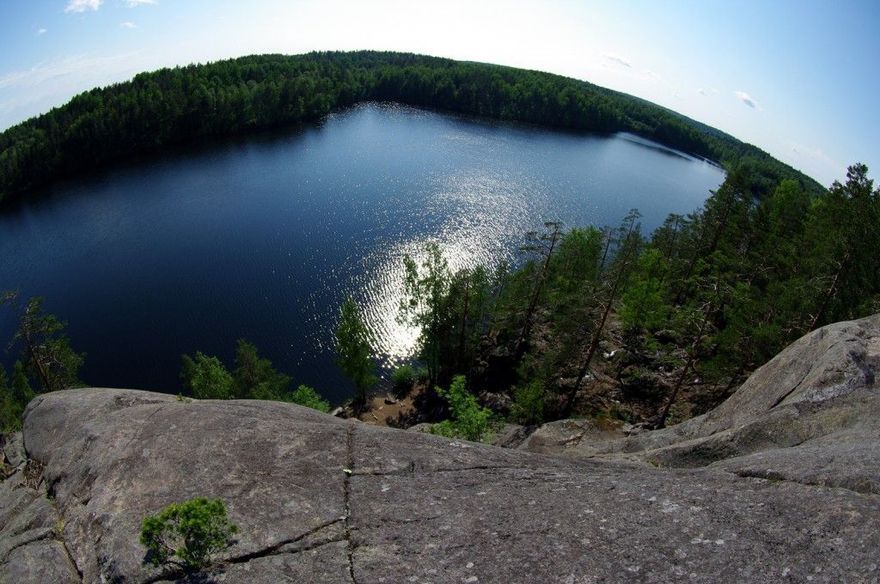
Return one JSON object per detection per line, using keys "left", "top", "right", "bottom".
{"left": 401, "top": 165, "right": 880, "bottom": 439}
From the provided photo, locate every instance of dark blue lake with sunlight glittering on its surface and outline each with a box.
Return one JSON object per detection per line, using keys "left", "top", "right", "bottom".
{"left": 0, "top": 105, "right": 724, "bottom": 402}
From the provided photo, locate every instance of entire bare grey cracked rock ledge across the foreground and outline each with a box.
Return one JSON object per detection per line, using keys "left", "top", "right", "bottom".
{"left": 0, "top": 316, "right": 880, "bottom": 584}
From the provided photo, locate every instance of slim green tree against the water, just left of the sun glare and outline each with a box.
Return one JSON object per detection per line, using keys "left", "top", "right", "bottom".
{"left": 336, "top": 298, "right": 378, "bottom": 404}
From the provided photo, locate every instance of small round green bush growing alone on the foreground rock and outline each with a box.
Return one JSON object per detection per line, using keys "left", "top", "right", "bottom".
{"left": 140, "top": 498, "right": 238, "bottom": 571}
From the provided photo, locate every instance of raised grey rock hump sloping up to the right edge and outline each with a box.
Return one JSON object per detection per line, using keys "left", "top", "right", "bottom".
{"left": 522, "top": 315, "right": 880, "bottom": 494}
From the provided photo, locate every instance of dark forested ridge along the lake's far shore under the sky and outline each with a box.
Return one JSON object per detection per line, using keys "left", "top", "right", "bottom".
{"left": 0, "top": 51, "right": 824, "bottom": 205}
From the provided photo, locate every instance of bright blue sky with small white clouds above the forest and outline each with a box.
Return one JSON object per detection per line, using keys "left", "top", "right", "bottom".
{"left": 0, "top": 0, "right": 880, "bottom": 185}
